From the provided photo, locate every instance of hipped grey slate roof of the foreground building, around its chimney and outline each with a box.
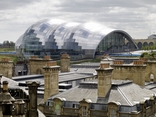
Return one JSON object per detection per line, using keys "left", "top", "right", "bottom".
{"left": 49, "top": 80, "right": 153, "bottom": 106}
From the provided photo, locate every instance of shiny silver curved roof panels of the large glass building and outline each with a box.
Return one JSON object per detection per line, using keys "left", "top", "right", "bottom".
{"left": 16, "top": 19, "right": 134, "bottom": 49}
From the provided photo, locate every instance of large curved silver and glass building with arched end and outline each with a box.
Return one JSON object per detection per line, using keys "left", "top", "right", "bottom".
{"left": 15, "top": 19, "right": 138, "bottom": 59}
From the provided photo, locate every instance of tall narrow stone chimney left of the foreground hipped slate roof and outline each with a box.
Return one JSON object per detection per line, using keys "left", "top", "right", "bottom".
{"left": 43, "top": 61, "right": 60, "bottom": 102}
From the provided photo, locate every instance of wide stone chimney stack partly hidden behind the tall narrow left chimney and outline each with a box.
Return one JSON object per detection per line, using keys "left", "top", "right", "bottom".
{"left": 28, "top": 56, "right": 52, "bottom": 74}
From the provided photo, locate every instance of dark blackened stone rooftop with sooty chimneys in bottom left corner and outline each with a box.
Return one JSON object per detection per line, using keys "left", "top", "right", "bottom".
{"left": 0, "top": 75, "right": 45, "bottom": 117}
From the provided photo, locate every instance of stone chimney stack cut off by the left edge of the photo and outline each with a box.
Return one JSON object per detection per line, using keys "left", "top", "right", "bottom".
{"left": 0, "top": 58, "right": 14, "bottom": 79}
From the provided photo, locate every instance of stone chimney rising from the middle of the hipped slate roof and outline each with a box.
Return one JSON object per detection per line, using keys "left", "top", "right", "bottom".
{"left": 96, "top": 63, "right": 113, "bottom": 98}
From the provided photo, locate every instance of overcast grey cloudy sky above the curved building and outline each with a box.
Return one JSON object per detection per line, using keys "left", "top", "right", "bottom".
{"left": 0, "top": 0, "right": 156, "bottom": 43}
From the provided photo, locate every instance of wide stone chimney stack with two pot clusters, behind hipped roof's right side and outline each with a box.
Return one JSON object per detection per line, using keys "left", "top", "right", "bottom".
{"left": 112, "top": 60, "right": 146, "bottom": 86}
